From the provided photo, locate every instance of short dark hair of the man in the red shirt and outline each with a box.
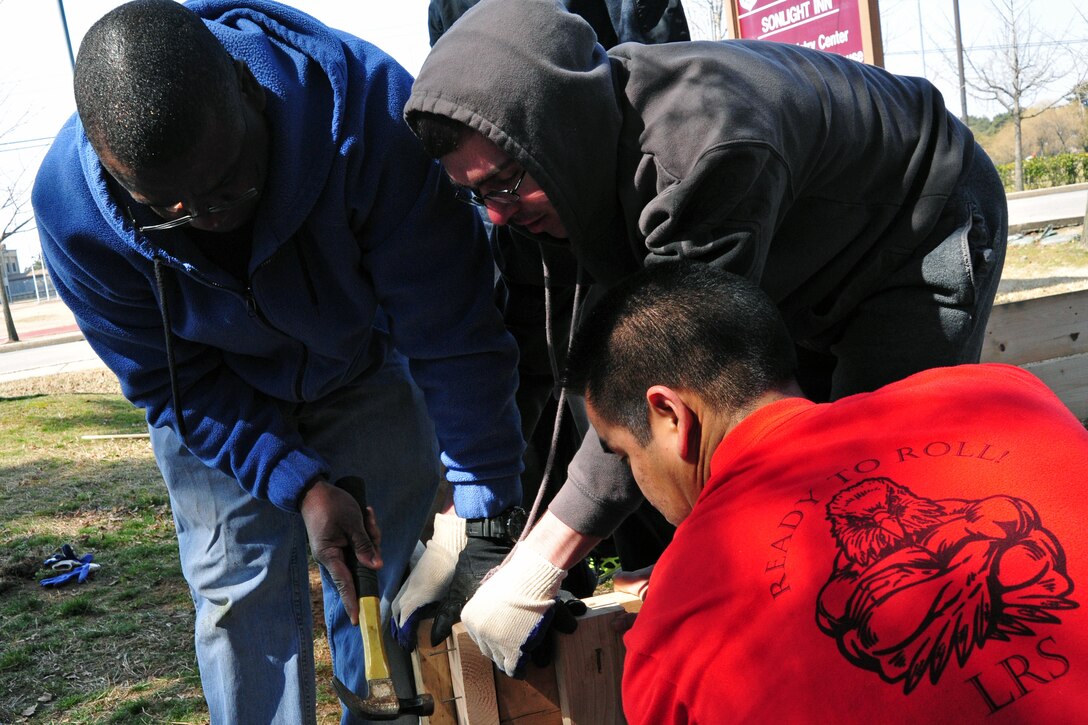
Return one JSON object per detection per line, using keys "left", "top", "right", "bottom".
{"left": 564, "top": 261, "right": 796, "bottom": 445}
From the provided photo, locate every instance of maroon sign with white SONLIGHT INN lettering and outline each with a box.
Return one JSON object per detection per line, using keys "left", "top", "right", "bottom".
{"left": 737, "top": 0, "right": 865, "bottom": 61}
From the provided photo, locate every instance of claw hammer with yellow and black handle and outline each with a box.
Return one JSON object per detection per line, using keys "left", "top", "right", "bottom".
{"left": 333, "top": 476, "right": 434, "bottom": 720}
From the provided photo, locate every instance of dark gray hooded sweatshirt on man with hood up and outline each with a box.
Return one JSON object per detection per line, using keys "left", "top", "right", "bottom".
{"left": 405, "top": 0, "right": 992, "bottom": 536}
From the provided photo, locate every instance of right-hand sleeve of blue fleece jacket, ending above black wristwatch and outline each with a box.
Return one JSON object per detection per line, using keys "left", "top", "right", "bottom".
{"left": 366, "top": 163, "right": 524, "bottom": 518}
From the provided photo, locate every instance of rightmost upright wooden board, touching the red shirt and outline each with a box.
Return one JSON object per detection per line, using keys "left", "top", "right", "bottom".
{"left": 555, "top": 593, "right": 642, "bottom": 725}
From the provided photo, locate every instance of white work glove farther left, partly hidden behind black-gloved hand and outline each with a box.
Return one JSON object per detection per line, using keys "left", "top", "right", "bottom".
{"left": 391, "top": 514, "right": 468, "bottom": 649}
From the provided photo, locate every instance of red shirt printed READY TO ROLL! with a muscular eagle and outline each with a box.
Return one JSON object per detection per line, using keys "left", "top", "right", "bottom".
{"left": 623, "top": 365, "right": 1088, "bottom": 725}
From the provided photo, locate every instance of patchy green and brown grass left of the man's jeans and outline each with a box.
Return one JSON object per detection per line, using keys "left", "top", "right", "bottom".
{"left": 0, "top": 376, "right": 339, "bottom": 724}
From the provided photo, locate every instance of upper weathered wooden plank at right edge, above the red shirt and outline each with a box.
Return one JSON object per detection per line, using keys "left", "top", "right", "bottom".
{"left": 982, "top": 290, "right": 1088, "bottom": 365}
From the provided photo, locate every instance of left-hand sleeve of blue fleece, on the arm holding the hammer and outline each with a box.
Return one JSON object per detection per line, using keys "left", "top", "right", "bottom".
{"left": 35, "top": 190, "right": 327, "bottom": 511}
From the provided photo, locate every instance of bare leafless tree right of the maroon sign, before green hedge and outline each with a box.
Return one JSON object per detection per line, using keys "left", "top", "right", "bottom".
{"left": 965, "top": 0, "right": 1067, "bottom": 191}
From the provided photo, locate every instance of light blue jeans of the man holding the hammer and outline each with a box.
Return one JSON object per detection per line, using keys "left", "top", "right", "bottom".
{"left": 151, "top": 356, "right": 441, "bottom": 725}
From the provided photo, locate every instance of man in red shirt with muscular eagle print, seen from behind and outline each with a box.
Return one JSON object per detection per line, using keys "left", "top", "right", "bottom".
{"left": 567, "top": 265, "right": 1088, "bottom": 725}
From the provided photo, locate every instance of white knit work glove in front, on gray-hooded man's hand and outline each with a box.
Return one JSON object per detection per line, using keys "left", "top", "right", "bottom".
{"left": 461, "top": 543, "right": 585, "bottom": 677}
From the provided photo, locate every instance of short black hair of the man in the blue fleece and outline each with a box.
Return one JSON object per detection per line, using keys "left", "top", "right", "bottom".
{"left": 75, "top": 0, "right": 238, "bottom": 171}
